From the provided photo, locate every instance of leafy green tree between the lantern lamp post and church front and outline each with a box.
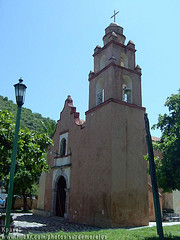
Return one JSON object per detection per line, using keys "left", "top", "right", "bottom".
{"left": 14, "top": 129, "right": 52, "bottom": 210}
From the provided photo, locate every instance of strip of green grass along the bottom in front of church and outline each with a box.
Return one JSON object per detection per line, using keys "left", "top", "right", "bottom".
{"left": 1, "top": 225, "right": 180, "bottom": 240}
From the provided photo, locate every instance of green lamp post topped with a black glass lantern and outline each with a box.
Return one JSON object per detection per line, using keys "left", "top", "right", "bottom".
{"left": 4, "top": 78, "right": 27, "bottom": 239}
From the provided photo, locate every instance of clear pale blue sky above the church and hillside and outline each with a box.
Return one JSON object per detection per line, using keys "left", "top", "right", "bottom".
{"left": 0, "top": 0, "right": 180, "bottom": 137}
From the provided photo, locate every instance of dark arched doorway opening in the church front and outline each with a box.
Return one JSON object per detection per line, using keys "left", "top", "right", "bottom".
{"left": 56, "top": 176, "right": 66, "bottom": 217}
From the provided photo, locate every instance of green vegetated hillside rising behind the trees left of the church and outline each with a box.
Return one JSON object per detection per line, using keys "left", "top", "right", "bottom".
{"left": 0, "top": 96, "right": 56, "bottom": 137}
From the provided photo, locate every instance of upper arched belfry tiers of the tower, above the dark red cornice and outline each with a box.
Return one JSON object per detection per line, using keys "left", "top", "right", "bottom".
{"left": 89, "top": 23, "right": 142, "bottom": 110}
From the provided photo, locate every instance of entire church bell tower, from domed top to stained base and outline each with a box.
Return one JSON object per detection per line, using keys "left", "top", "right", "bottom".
{"left": 86, "top": 20, "right": 149, "bottom": 227}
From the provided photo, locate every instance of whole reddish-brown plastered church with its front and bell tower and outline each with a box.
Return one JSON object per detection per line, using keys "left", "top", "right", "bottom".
{"left": 36, "top": 23, "right": 149, "bottom": 227}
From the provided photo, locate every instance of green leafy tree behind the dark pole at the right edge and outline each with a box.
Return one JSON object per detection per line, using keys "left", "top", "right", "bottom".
{"left": 153, "top": 90, "right": 180, "bottom": 192}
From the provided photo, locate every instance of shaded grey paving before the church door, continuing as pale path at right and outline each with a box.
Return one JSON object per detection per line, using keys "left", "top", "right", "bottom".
{"left": 0, "top": 213, "right": 180, "bottom": 235}
